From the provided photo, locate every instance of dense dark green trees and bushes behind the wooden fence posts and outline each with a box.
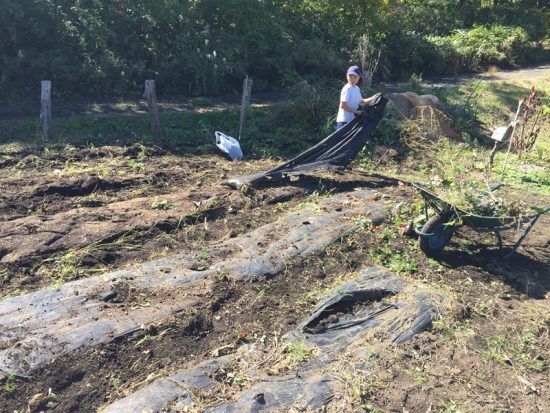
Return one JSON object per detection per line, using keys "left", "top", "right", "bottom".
{"left": 0, "top": 0, "right": 549, "bottom": 98}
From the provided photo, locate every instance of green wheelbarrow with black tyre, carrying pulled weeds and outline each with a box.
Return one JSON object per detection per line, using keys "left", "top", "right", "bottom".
{"left": 404, "top": 183, "right": 550, "bottom": 259}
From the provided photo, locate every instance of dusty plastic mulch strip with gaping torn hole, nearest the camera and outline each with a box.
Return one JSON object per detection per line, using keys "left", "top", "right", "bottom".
{"left": 103, "top": 267, "right": 443, "bottom": 413}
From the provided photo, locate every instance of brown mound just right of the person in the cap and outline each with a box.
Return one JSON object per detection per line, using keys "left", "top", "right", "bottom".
{"left": 386, "top": 92, "right": 460, "bottom": 139}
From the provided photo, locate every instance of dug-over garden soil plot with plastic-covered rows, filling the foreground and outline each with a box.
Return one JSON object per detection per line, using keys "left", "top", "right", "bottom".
{"left": 0, "top": 136, "right": 550, "bottom": 412}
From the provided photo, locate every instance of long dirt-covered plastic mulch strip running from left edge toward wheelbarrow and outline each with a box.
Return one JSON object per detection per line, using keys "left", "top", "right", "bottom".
{"left": 0, "top": 189, "right": 390, "bottom": 376}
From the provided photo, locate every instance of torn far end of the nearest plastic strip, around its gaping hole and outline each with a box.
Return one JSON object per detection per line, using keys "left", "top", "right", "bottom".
{"left": 287, "top": 267, "right": 442, "bottom": 347}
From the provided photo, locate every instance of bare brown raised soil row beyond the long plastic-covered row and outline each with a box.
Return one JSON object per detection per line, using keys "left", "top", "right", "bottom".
{"left": 0, "top": 187, "right": 229, "bottom": 264}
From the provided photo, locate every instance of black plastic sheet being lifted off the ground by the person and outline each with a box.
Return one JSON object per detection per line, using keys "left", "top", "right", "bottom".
{"left": 225, "top": 93, "right": 388, "bottom": 189}
